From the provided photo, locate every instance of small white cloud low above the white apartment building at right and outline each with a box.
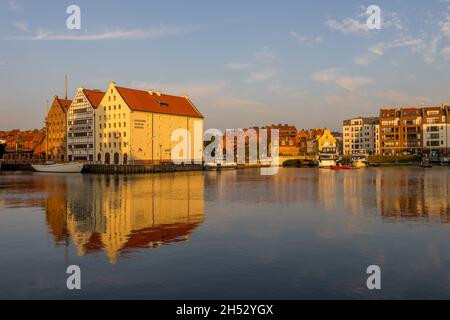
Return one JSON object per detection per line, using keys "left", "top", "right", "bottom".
{"left": 313, "top": 68, "right": 373, "bottom": 92}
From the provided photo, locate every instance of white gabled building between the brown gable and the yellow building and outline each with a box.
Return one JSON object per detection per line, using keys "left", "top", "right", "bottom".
{"left": 67, "top": 88, "right": 105, "bottom": 161}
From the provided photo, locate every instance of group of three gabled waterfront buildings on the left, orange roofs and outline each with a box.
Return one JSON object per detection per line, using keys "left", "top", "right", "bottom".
{"left": 46, "top": 82, "right": 204, "bottom": 164}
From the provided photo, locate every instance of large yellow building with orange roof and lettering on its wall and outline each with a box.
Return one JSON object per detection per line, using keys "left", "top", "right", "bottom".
{"left": 95, "top": 82, "right": 204, "bottom": 164}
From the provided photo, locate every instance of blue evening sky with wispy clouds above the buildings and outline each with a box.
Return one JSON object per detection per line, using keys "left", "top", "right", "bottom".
{"left": 0, "top": 0, "right": 450, "bottom": 130}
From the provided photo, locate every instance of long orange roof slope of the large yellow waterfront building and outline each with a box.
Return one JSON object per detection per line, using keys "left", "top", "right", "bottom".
{"left": 116, "top": 87, "right": 203, "bottom": 118}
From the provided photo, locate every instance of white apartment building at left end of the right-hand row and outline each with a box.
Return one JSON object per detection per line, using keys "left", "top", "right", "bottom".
{"left": 342, "top": 117, "right": 380, "bottom": 155}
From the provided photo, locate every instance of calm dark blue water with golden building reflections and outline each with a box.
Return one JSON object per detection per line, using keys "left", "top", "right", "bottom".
{"left": 0, "top": 168, "right": 450, "bottom": 299}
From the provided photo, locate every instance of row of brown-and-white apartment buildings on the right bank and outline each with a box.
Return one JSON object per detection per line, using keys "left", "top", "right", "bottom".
{"left": 343, "top": 105, "right": 450, "bottom": 155}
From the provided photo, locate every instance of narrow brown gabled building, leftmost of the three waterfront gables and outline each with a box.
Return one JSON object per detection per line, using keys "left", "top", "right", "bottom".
{"left": 45, "top": 96, "right": 72, "bottom": 162}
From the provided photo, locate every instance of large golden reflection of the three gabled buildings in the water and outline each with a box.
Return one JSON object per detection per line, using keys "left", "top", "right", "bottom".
{"left": 46, "top": 174, "right": 204, "bottom": 263}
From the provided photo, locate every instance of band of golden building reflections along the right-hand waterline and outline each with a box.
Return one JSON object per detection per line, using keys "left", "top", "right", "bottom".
{"left": 206, "top": 167, "right": 450, "bottom": 223}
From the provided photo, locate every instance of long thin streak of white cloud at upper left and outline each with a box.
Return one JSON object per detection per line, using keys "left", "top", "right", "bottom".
{"left": 10, "top": 26, "right": 195, "bottom": 41}
